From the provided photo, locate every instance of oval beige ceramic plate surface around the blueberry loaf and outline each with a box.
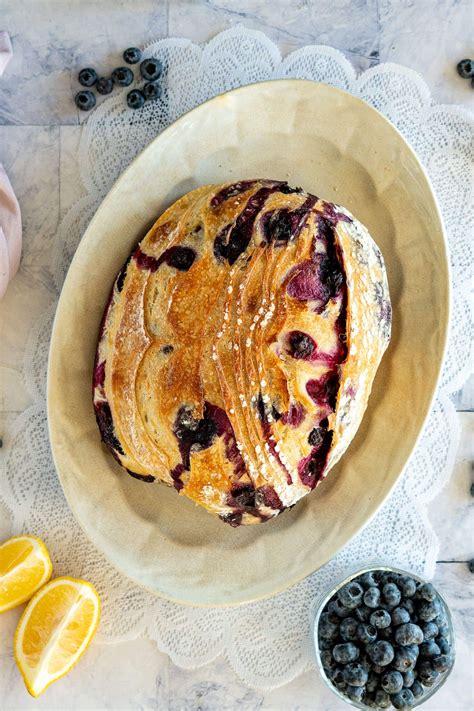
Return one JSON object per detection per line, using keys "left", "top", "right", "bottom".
{"left": 48, "top": 80, "right": 449, "bottom": 605}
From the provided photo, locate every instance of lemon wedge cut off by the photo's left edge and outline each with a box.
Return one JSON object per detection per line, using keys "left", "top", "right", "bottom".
{"left": 0, "top": 536, "right": 53, "bottom": 612}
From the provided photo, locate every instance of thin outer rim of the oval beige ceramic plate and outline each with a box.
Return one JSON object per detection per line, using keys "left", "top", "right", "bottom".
{"left": 46, "top": 78, "right": 452, "bottom": 608}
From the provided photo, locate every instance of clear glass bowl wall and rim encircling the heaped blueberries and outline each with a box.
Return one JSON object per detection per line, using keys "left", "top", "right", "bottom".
{"left": 313, "top": 565, "right": 456, "bottom": 711}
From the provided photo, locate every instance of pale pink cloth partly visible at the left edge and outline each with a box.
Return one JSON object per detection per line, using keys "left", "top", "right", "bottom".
{"left": 0, "top": 32, "right": 21, "bottom": 299}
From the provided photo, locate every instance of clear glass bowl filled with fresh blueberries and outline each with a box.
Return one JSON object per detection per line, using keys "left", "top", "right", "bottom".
{"left": 314, "top": 566, "right": 455, "bottom": 709}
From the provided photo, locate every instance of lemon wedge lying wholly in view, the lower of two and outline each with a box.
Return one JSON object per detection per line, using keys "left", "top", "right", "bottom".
{"left": 14, "top": 577, "right": 100, "bottom": 696}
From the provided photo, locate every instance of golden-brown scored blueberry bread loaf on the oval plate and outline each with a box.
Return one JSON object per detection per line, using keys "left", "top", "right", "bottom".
{"left": 94, "top": 180, "right": 391, "bottom": 526}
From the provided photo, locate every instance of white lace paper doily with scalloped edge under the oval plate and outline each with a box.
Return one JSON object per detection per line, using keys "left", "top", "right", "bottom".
{"left": 0, "top": 27, "right": 473, "bottom": 688}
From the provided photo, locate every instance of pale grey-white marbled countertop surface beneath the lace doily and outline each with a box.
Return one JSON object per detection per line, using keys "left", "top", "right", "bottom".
{"left": 0, "top": 0, "right": 474, "bottom": 711}
